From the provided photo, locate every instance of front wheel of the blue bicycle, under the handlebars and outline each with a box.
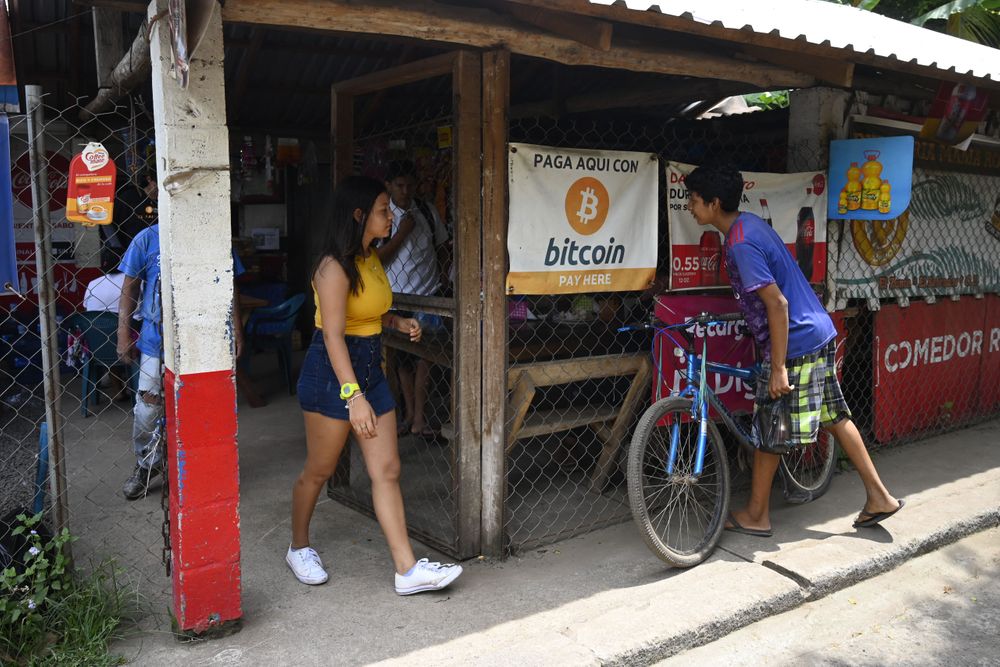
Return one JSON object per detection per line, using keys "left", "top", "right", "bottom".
{"left": 628, "top": 396, "right": 729, "bottom": 567}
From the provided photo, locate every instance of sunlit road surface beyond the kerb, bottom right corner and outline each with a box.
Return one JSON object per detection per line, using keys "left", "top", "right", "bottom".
{"left": 659, "top": 528, "right": 1000, "bottom": 667}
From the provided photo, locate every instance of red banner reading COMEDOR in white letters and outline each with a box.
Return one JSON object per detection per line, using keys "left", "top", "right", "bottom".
{"left": 872, "top": 297, "right": 1000, "bottom": 442}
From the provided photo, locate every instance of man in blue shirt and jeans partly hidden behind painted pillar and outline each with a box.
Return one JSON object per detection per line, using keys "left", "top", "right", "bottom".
{"left": 118, "top": 215, "right": 244, "bottom": 500}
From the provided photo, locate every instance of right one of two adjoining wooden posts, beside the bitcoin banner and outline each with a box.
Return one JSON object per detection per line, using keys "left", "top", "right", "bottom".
{"left": 482, "top": 51, "right": 510, "bottom": 558}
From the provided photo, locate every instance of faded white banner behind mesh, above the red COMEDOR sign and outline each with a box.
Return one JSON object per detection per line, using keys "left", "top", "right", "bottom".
{"left": 831, "top": 167, "right": 1000, "bottom": 300}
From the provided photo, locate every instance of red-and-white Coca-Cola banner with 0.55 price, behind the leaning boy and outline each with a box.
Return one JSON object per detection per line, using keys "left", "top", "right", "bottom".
{"left": 667, "top": 162, "right": 827, "bottom": 290}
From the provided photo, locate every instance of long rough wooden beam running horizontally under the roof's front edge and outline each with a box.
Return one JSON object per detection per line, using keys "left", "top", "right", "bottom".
{"left": 223, "top": 0, "right": 815, "bottom": 89}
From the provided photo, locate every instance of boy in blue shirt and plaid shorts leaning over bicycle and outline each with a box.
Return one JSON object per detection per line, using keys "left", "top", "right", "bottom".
{"left": 685, "top": 166, "right": 903, "bottom": 537}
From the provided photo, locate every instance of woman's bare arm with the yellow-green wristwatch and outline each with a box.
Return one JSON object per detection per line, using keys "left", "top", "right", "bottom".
{"left": 313, "top": 258, "right": 376, "bottom": 438}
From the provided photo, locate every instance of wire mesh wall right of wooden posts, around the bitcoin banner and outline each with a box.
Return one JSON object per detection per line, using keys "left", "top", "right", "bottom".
{"left": 504, "top": 111, "right": 1000, "bottom": 552}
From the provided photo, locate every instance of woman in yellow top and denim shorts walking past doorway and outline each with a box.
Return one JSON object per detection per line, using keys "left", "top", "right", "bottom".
{"left": 285, "top": 176, "right": 462, "bottom": 595}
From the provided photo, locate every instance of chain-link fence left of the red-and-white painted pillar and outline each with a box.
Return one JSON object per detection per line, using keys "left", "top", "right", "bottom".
{"left": 0, "top": 96, "right": 170, "bottom": 608}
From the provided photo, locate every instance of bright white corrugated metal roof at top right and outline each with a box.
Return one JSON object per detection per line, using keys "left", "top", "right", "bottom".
{"left": 590, "top": 0, "right": 1000, "bottom": 81}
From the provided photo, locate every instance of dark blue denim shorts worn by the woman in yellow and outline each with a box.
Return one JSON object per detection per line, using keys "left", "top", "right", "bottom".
{"left": 298, "top": 330, "right": 396, "bottom": 421}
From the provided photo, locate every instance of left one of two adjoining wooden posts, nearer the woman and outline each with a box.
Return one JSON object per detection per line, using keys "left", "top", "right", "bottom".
{"left": 452, "top": 51, "right": 483, "bottom": 558}
